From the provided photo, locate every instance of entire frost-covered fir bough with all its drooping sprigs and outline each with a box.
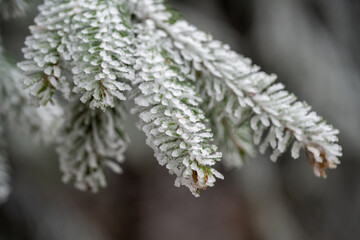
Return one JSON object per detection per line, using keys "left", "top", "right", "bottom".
{"left": 12, "top": 0, "right": 341, "bottom": 195}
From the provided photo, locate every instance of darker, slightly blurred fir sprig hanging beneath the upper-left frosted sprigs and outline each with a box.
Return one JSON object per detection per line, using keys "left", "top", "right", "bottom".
{"left": 57, "top": 101, "right": 129, "bottom": 192}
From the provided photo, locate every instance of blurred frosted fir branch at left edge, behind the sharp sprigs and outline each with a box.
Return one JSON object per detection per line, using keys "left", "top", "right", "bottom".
{"left": 0, "top": 43, "right": 62, "bottom": 142}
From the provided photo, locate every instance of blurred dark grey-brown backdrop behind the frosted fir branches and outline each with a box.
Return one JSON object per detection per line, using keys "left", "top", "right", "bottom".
{"left": 0, "top": 0, "right": 360, "bottom": 240}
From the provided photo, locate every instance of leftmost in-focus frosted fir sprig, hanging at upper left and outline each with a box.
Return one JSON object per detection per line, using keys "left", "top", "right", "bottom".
{"left": 18, "top": 0, "right": 77, "bottom": 105}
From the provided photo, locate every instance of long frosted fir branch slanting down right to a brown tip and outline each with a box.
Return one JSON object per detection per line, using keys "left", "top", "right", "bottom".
{"left": 131, "top": 0, "right": 342, "bottom": 177}
